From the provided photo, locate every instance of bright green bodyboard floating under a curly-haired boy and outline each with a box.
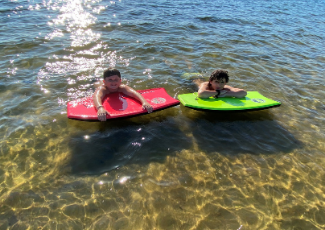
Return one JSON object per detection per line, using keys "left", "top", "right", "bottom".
{"left": 178, "top": 91, "right": 281, "bottom": 111}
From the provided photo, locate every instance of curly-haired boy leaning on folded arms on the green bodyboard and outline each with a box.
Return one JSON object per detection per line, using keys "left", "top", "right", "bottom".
{"left": 198, "top": 69, "right": 247, "bottom": 98}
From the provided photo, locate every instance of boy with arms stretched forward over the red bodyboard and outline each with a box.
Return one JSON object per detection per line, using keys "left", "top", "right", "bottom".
{"left": 93, "top": 68, "right": 152, "bottom": 121}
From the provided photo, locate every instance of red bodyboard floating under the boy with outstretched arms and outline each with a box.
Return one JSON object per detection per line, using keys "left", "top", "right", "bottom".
{"left": 67, "top": 88, "right": 179, "bottom": 120}
